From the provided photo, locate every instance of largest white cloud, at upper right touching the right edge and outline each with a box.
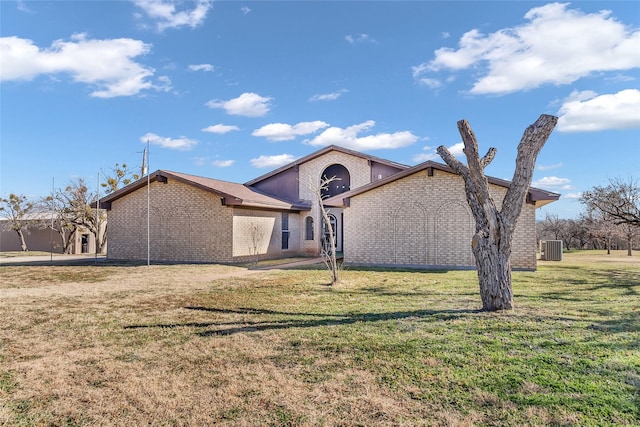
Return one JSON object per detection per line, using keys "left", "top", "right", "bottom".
{"left": 413, "top": 3, "right": 640, "bottom": 94}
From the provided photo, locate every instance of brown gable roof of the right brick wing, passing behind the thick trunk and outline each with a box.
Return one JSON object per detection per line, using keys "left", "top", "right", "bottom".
{"left": 324, "top": 160, "right": 560, "bottom": 207}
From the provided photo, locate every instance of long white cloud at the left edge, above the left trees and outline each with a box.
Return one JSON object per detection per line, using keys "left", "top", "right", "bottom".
{"left": 0, "top": 34, "right": 161, "bottom": 98}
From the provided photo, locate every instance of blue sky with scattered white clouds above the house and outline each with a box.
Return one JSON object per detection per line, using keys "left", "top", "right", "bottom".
{"left": 0, "top": 0, "right": 640, "bottom": 218}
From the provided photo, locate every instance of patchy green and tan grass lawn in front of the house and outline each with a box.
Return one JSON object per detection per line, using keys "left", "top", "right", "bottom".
{"left": 0, "top": 252, "right": 640, "bottom": 426}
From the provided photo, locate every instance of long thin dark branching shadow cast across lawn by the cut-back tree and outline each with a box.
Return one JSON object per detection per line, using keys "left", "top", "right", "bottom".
{"left": 125, "top": 307, "right": 480, "bottom": 337}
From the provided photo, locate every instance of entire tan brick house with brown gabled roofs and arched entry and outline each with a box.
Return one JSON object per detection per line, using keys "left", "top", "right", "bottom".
{"left": 100, "top": 146, "right": 559, "bottom": 269}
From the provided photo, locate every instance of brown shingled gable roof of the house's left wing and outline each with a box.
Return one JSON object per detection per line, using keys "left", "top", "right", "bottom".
{"left": 100, "top": 170, "right": 310, "bottom": 211}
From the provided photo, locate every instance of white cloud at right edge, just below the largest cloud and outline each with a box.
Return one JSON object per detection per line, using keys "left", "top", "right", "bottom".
{"left": 558, "top": 89, "right": 640, "bottom": 132}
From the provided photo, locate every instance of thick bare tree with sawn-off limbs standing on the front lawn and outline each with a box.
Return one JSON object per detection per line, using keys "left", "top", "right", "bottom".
{"left": 437, "top": 114, "right": 558, "bottom": 311}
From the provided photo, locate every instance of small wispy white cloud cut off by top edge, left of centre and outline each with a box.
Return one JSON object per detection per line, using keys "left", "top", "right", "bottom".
{"left": 133, "top": 0, "right": 213, "bottom": 32}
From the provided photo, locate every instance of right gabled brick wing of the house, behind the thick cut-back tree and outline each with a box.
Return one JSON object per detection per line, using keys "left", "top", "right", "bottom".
{"left": 325, "top": 161, "right": 559, "bottom": 270}
